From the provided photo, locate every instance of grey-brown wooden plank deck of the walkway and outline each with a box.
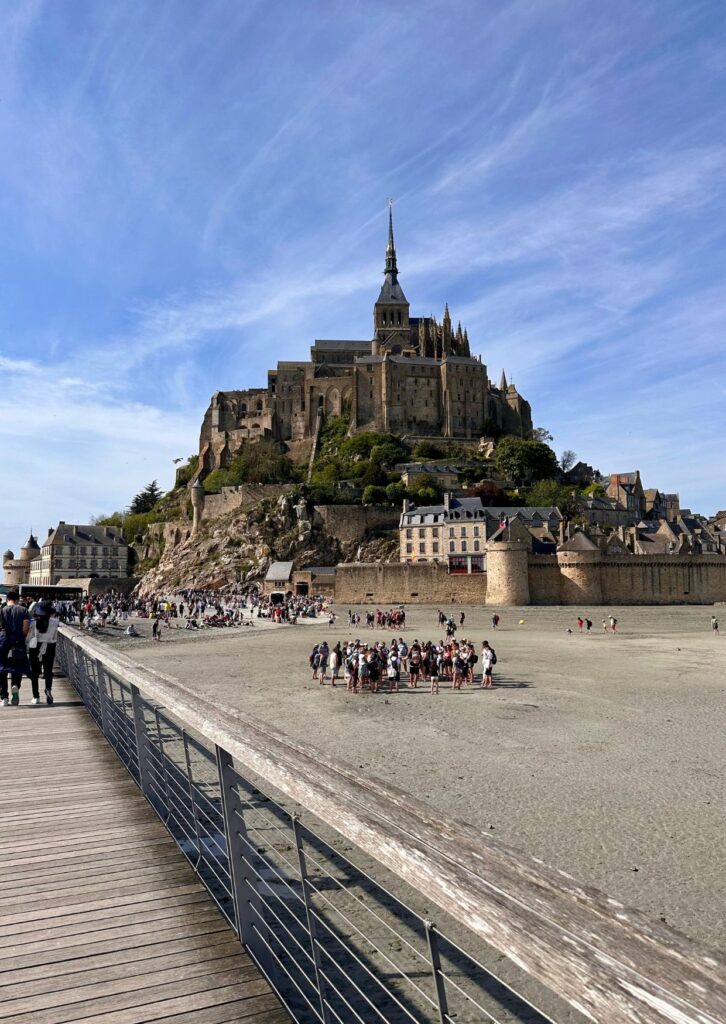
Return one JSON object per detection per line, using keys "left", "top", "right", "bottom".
{"left": 0, "top": 680, "right": 290, "bottom": 1024}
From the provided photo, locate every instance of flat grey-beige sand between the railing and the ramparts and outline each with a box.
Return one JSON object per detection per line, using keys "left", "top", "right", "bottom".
{"left": 104, "top": 605, "right": 726, "bottom": 948}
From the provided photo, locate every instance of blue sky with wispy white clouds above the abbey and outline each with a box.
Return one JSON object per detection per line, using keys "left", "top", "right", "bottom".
{"left": 0, "top": 0, "right": 726, "bottom": 549}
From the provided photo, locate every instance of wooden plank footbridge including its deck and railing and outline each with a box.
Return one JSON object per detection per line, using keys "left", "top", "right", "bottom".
{"left": 0, "top": 627, "right": 726, "bottom": 1024}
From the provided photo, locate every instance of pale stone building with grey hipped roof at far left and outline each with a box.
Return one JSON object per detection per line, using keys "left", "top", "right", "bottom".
{"left": 28, "top": 522, "right": 129, "bottom": 586}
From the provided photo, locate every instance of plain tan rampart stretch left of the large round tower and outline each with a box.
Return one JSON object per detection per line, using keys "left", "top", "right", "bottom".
{"left": 335, "top": 562, "right": 486, "bottom": 605}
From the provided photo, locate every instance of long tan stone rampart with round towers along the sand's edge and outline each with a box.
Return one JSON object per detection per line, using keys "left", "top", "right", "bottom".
{"left": 335, "top": 557, "right": 726, "bottom": 607}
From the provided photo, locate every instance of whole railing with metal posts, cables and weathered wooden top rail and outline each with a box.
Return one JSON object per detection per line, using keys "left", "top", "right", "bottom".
{"left": 58, "top": 628, "right": 726, "bottom": 1024}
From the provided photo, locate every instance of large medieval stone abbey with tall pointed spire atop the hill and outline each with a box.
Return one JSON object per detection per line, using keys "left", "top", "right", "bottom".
{"left": 200, "top": 209, "right": 531, "bottom": 474}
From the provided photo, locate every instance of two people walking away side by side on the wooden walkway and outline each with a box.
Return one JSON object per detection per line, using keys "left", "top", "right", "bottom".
{"left": 0, "top": 590, "right": 60, "bottom": 708}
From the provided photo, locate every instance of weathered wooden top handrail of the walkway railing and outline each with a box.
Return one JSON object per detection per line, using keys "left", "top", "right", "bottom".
{"left": 61, "top": 627, "right": 726, "bottom": 1024}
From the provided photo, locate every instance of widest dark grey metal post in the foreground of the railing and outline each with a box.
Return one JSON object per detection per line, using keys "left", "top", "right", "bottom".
{"left": 215, "top": 744, "right": 276, "bottom": 978}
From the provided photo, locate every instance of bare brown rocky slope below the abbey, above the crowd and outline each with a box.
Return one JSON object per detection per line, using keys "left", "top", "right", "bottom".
{"left": 139, "top": 495, "right": 398, "bottom": 593}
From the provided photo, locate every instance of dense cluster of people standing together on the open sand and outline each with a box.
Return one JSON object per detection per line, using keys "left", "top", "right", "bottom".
{"left": 308, "top": 637, "right": 497, "bottom": 693}
